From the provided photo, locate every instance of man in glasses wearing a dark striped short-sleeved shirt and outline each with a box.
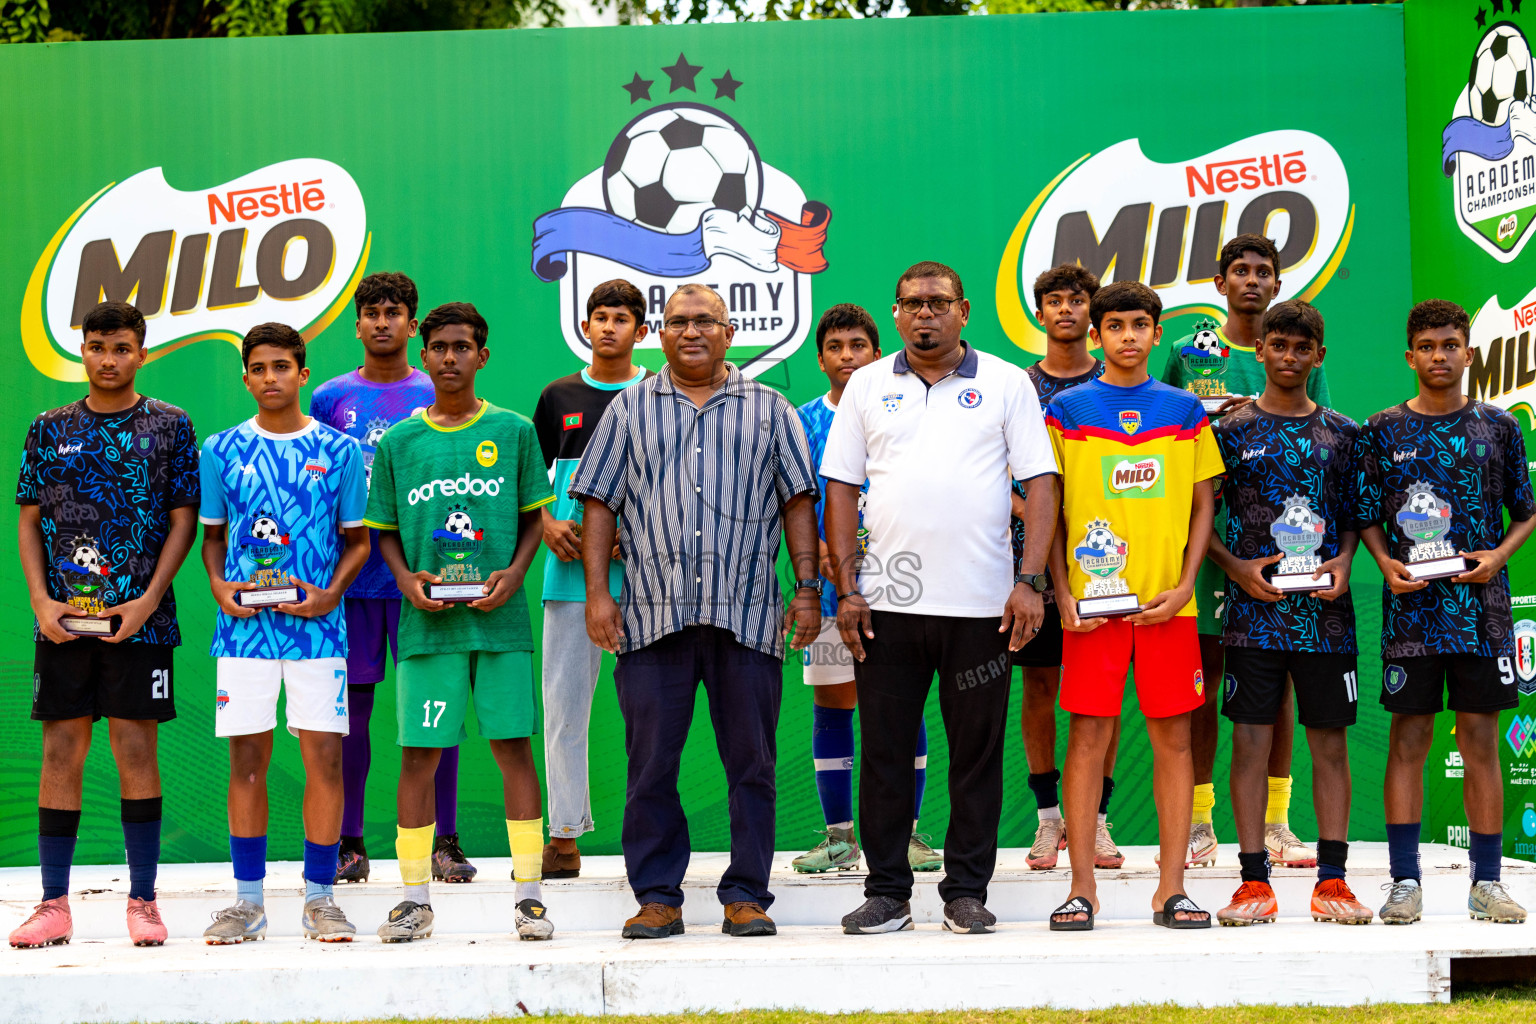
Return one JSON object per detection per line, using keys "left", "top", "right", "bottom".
{"left": 570, "top": 284, "right": 822, "bottom": 938}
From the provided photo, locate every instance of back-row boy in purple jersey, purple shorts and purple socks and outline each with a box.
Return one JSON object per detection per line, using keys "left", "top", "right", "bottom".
{"left": 309, "top": 273, "right": 463, "bottom": 881}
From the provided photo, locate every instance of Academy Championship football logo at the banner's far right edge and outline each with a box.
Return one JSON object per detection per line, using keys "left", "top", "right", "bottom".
{"left": 1441, "top": 21, "right": 1536, "bottom": 263}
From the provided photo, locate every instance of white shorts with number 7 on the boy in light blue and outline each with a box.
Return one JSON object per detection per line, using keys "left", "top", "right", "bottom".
{"left": 214, "top": 657, "right": 350, "bottom": 737}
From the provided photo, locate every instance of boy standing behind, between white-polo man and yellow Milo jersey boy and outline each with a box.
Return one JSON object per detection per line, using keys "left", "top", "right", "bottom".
{"left": 1011, "top": 263, "right": 1126, "bottom": 870}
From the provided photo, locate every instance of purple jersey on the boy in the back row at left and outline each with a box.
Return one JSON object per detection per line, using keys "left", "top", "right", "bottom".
{"left": 309, "top": 367, "right": 433, "bottom": 600}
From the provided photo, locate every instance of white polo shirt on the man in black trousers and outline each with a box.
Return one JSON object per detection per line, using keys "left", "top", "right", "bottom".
{"left": 822, "top": 345, "right": 1057, "bottom": 619}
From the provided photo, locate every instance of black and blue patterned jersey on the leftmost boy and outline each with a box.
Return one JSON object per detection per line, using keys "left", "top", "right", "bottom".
{"left": 15, "top": 398, "right": 198, "bottom": 645}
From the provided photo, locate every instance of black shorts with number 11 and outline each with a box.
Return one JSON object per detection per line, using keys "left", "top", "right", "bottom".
{"left": 1221, "top": 646, "right": 1359, "bottom": 729}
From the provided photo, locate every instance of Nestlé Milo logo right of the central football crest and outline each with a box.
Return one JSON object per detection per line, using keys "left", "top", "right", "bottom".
{"left": 997, "top": 129, "right": 1355, "bottom": 354}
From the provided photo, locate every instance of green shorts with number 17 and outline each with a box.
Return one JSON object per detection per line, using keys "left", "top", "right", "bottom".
{"left": 395, "top": 651, "right": 539, "bottom": 748}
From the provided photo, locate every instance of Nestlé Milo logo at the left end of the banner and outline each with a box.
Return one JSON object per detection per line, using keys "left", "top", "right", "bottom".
{"left": 22, "top": 157, "right": 370, "bottom": 381}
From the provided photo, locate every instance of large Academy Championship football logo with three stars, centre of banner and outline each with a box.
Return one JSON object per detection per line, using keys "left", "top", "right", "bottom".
{"left": 533, "top": 54, "right": 833, "bottom": 376}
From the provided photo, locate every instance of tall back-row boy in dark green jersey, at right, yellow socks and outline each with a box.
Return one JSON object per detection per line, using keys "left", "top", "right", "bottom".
{"left": 1163, "top": 235, "right": 1330, "bottom": 867}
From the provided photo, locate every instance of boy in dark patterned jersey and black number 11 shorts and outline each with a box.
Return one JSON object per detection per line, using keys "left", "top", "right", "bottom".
{"left": 1210, "top": 301, "right": 1372, "bottom": 924}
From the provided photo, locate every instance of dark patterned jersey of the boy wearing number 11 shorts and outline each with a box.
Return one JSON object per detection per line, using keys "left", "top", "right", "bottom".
{"left": 1212, "top": 402, "right": 1359, "bottom": 654}
